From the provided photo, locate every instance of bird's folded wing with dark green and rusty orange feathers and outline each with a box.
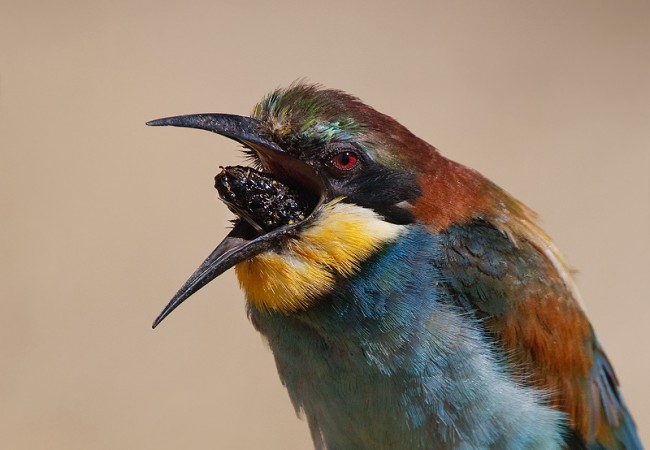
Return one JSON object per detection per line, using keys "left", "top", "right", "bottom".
{"left": 432, "top": 214, "right": 641, "bottom": 448}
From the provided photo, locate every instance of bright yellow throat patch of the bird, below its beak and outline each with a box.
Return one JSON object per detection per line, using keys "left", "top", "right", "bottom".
{"left": 235, "top": 200, "right": 405, "bottom": 313}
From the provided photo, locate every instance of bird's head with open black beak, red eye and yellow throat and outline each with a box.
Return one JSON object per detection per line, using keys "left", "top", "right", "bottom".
{"left": 148, "top": 83, "right": 528, "bottom": 326}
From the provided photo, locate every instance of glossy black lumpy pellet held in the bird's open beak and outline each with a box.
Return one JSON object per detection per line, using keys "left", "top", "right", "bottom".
{"left": 214, "top": 166, "right": 309, "bottom": 231}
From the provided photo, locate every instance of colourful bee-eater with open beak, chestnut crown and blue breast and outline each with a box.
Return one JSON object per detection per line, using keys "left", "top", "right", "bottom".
{"left": 147, "top": 80, "right": 642, "bottom": 450}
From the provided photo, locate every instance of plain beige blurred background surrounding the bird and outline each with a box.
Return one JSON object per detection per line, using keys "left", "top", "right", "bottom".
{"left": 0, "top": 0, "right": 650, "bottom": 450}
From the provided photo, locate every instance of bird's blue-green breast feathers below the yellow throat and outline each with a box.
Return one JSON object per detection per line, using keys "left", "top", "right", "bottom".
{"left": 250, "top": 226, "right": 563, "bottom": 449}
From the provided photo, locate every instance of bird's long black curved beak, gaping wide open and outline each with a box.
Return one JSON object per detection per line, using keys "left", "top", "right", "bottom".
{"left": 147, "top": 114, "right": 321, "bottom": 328}
